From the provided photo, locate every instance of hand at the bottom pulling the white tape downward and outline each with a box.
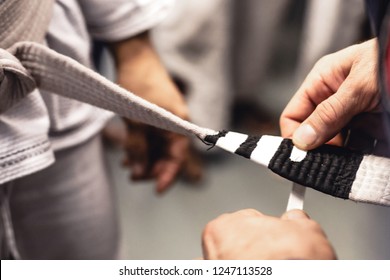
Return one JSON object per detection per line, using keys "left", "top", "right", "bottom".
{"left": 202, "top": 209, "right": 336, "bottom": 259}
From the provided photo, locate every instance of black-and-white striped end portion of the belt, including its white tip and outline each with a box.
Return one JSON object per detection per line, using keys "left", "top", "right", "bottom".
{"left": 205, "top": 131, "right": 390, "bottom": 206}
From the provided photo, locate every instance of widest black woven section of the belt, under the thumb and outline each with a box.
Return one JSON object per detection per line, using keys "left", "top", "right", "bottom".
{"left": 268, "top": 139, "right": 363, "bottom": 199}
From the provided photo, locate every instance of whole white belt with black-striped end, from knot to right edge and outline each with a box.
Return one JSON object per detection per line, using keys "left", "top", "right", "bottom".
{"left": 0, "top": 42, "right": 390, "bottom": 205}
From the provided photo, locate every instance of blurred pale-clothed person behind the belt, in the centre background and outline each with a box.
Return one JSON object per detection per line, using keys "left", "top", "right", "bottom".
{"left": 152, "top": 0, "right": 294, "bottom": 137}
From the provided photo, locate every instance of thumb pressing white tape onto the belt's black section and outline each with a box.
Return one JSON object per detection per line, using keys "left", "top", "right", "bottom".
{"left": 292, "top": 91, "right": 354, "bottom": 150}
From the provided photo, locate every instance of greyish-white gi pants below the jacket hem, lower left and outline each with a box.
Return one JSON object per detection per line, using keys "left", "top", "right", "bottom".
{"left": 0, "top": 137, "right": 119, "bottom": 259}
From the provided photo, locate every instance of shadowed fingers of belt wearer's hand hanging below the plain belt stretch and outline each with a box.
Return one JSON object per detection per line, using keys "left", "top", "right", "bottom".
{"left": 124, "top": 119, "right": 202, "bottom": 193}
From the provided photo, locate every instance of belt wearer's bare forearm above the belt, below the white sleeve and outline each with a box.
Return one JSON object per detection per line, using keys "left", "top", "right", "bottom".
{"left": 110, "top": 32, "right": 188, "bottom": 119}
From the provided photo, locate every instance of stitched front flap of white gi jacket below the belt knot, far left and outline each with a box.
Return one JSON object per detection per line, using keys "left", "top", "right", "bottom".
{"left": 0, "top": 90, "right": 54, "bottom": 185}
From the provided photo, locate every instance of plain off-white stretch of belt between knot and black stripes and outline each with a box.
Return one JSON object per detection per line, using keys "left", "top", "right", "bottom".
{"left": 0, "top": 42, "right": 217, "bottom": 139}
